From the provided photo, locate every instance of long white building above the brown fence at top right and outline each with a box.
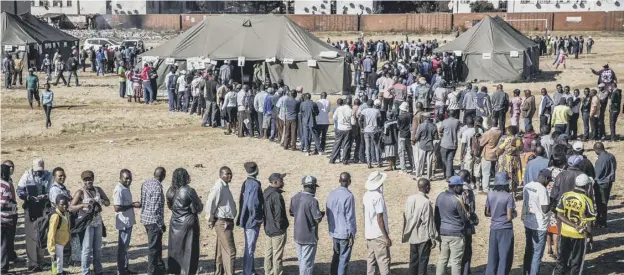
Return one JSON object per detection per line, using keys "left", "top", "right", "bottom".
{"left": 449, "top": 0, "right": 624, "bottom": 13}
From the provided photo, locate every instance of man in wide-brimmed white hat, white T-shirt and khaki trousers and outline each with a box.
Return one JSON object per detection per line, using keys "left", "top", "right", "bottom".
{"left": 362, "top": 171, "right": 392, "bottom": 275}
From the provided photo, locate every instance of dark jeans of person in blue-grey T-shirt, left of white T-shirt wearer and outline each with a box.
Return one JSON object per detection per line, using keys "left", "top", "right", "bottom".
{"left": 485, "top": 228, "right": 514, "bottom": 275}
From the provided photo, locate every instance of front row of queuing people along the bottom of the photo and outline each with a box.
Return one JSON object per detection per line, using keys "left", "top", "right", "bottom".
{"left": 0, "top": 136, "right": 617, "bottom": 275}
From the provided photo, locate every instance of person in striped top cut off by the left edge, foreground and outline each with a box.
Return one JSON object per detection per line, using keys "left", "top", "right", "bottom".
{"left": 0, "top": 164, "right": 17, "bottom": 274}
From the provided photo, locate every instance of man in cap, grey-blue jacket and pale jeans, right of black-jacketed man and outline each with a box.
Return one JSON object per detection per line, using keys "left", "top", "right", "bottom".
{"left": 289, "top": 176, "right": 325, "bottom": 275}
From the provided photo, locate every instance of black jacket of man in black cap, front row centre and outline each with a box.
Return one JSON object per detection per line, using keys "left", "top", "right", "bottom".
{"left": 263, "top": 186, "right": 289, "bottom": 237}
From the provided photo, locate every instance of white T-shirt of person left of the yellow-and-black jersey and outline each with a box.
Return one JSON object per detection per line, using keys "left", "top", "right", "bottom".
{"left": 522, "top": 181, "right": 550, "bottom": 231}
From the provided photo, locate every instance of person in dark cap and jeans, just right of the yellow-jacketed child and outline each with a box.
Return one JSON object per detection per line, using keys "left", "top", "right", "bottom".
{"left": 69, "top": 171, "right": 110, "bottom": 275}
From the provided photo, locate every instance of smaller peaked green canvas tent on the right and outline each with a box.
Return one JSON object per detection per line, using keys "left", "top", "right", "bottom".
{"left": 434, "top": 16, "right": 539, "bottom": 81}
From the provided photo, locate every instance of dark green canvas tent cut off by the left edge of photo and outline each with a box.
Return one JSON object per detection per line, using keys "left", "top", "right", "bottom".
{"left": 2, "top": 12, "right": 79, "bottom": 67}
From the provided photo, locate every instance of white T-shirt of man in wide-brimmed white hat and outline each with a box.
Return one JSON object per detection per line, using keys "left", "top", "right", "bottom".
{"left": 362, "top": 190, "right": 390, "bottom": 240}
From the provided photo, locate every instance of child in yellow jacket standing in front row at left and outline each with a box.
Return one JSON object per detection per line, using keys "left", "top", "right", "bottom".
{"left": 47, "top": 195, "right": 69, "bottom": 275}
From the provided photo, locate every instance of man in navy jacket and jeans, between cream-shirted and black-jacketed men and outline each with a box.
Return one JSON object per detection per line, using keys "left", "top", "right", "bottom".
{"left": 236, "top": 162, "right": 264, "bottom": 275}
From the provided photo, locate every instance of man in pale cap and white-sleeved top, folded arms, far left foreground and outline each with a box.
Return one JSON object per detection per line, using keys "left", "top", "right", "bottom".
{"left": 17, "top": 158, "right": 53, "bottom": 272}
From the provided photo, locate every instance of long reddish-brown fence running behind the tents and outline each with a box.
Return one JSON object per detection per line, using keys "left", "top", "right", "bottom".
{"left": 91, "top": 11, "right": 624, "bottom": 33}
